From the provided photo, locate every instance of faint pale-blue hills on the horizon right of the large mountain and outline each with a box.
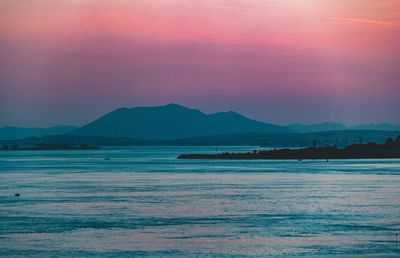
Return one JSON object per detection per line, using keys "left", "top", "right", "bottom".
{"left": 288, "top": 123, "right": 400, "bottom": 133}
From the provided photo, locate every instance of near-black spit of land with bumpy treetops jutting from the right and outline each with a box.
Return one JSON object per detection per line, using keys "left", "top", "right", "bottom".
{"left": 178, "top": 136, "right": 400, "bottom": 159}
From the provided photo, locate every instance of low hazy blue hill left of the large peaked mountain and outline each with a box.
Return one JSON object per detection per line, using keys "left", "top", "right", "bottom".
{"left": 0, "top": 125, "right": 78, "bottom": 140}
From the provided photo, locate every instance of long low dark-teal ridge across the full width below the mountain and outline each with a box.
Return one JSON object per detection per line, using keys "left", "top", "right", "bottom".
{"left": 0, "top": 130, "right": 399, "bottom": 147}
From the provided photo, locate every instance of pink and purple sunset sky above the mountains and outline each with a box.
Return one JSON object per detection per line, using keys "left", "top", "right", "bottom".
{"left": 0, "top": 0, "right": 400, "bottom": 127}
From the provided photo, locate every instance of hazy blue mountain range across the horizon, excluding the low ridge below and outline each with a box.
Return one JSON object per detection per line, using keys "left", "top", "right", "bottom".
{"left": 0, "top": 104, "right": 400, "bottom": 141}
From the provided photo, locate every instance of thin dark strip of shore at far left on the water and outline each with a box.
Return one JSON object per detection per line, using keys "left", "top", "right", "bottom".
{"left": 0, "top": 143, "right": 99, "bottom": 151}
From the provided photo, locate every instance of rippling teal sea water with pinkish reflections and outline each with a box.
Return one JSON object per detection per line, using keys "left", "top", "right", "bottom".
{"left": 0, "top": 147, "right": 400, "bottom": 257}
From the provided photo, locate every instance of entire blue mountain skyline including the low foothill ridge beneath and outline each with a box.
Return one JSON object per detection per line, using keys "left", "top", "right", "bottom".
{"left": 0, "top": 104, "right": 400, "bottom": 143}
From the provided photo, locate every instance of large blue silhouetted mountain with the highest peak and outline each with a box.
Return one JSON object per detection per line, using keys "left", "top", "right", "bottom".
{"left": 73, "top": 104, "right": 293, "bottom": 140}
